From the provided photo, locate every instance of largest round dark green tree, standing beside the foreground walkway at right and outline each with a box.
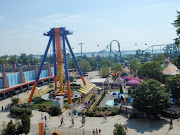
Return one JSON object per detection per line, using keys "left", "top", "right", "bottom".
{"left": 132, "top": 79, "right": 170, "bottom": 114}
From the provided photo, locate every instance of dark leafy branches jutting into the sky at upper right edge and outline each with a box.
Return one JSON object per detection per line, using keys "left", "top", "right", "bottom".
{"left": 172, "top": 11, "right": 180, "bottom": 46}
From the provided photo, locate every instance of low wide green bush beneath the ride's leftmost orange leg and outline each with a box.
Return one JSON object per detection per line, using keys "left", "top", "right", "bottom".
{"left": 10, "top": 107, "right": 32, "bottom": 116}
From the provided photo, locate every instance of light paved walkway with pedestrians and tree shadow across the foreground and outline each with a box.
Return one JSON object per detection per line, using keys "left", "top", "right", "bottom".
{"left": 0, "top": 110, "right": 180, "bottom": 135}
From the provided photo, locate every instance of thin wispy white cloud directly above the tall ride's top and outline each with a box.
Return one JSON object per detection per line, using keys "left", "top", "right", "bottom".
{"left": 40, "top": 14, "right": 80, "bottom": 23}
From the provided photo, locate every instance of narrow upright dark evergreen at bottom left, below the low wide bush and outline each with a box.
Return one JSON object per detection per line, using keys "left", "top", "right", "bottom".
{"left": 21, "top": 113, "right": 31, "bottom": 134}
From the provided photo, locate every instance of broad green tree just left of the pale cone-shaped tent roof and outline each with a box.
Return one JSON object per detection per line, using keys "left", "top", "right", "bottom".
{"left": 138, "top": 61, "right": 163, "bottom": 81}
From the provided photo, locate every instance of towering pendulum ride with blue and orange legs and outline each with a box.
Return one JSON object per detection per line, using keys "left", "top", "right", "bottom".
{"left": 28, "top": 27, "right": 86, "bottom": 104}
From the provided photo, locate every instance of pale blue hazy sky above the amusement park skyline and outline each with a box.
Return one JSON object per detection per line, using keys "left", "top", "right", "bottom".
{"left": 0, "top": 0, "right": 180, "bottom": 56}
